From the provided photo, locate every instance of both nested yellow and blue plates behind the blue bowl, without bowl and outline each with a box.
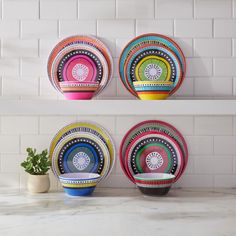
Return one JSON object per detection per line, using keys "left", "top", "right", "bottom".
{"left": 49, "top": 122, "right": 115, "bottom": 182}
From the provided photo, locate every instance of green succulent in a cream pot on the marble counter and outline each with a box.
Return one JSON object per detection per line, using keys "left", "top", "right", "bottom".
{"left": 21, "top": 148, "right": 51, "bottom": 193}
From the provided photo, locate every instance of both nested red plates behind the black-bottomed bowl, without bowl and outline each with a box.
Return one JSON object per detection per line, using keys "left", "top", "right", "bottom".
{"left": 120, "top": 120, "right": 188, "bottom": 195}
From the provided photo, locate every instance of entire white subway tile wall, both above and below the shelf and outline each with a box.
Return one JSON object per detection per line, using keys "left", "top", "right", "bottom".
{"left": 0, "top": 0, "right": 236, "bottom": 190}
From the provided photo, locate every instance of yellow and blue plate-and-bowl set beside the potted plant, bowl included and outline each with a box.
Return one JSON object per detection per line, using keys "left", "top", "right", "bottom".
{"left": 49, "top": 122, "right": 115, "bottom": 196}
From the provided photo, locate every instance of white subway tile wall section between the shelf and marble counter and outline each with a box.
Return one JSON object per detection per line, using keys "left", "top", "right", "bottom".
{"left": 0, "top": 115, "right": 236, "bottom": 190}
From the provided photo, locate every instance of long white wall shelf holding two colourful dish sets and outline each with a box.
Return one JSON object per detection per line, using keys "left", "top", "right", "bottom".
{"left": 0, "top": 100, "right": 236, "bottom": 115}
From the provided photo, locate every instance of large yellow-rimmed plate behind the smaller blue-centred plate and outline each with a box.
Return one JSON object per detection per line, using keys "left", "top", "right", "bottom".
{"left": 49, "top": 121, "right": 116, "bottom": 179}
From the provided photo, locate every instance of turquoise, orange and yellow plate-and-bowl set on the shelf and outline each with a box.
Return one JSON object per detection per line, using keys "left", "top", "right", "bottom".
{"left": 119, "top": 34, "right": 186, "bottom": 100}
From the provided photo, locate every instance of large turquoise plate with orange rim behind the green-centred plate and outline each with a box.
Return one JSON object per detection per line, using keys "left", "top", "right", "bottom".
{"left": 119, "top": 34, "right": 186, "bottom": 94}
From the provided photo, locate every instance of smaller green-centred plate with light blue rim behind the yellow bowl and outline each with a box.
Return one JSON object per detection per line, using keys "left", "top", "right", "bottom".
{"left": 124, "top": 45, "right": 182, "bottom": 94}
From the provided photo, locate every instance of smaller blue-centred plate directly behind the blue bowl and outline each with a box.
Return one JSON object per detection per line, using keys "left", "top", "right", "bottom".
{"left": 52, "top": 132, "right": 110, "bottom": 179}
